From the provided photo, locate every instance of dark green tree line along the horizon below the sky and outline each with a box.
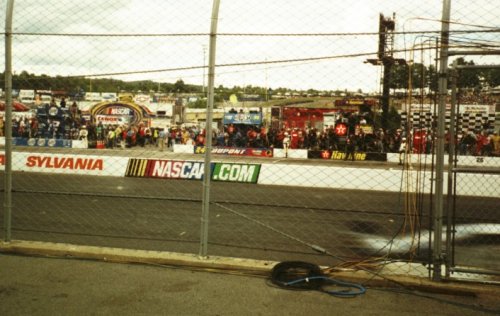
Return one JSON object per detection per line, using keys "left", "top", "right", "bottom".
{"left": 0, "top": 58, "right": 500, "bottom": 100}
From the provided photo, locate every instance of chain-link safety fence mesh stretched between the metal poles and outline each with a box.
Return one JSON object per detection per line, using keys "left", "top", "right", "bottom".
{"left": 0, "top": 0, "right": 500, "bottom": 282}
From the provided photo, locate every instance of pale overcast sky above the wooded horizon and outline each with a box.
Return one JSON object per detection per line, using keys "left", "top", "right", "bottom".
{"left": 0, "top": 0, "right": 500, "bottom": 92}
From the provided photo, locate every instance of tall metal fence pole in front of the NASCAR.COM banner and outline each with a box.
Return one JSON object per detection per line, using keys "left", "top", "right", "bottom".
{"left": 200, "top": 0, "right": 220, "bottom": 258}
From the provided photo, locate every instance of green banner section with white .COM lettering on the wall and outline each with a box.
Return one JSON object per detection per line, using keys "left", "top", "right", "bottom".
{"left": 212, "top": 163, "right": 260, "bottom": 183}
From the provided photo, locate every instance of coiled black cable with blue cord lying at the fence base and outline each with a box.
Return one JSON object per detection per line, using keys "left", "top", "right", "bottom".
{"left": 271, "top": 261, "right": 366, "bottom": 297}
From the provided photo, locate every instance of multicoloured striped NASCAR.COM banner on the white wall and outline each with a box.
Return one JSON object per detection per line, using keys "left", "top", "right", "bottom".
{"left": 125, "top": 158, "right": 260, "bottom": 183}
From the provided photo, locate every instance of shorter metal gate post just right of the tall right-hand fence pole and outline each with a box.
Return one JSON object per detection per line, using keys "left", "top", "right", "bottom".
{"left": 445, "top": 61, "right": 457, "bottom": 278}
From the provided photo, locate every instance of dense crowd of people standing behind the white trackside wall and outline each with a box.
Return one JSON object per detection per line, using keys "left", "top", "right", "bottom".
{"left": 0, "top": 99, "right": 500, "bottom": 156}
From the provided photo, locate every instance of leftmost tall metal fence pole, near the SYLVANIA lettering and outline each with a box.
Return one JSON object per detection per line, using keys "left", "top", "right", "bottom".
{"left": 3, "top": 0, "right": 14, "bottom": 242}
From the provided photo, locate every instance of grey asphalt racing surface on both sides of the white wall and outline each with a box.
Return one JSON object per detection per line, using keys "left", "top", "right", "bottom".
{"left": 0, "top": 148, "right": 500, "bottom": 276}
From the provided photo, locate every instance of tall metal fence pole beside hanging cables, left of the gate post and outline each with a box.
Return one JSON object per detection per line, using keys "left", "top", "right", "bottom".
{"left": 432, "top": 0, "right": 451, "bottom": 281}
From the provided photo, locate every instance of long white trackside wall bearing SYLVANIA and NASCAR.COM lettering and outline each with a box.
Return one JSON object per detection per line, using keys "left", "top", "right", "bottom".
{"left": 0, "top": 147, "right": 500, "bottom": 198}
